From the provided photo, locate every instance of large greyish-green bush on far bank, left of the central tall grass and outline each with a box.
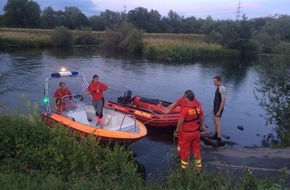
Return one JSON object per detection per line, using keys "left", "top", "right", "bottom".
{"left": 103, "top": 23, "right": 143, "bottom": 53}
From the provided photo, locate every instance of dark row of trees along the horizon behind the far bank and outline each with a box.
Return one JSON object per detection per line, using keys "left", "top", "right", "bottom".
{"left": 0, "top": 0, "right": 290, "bottom": 58}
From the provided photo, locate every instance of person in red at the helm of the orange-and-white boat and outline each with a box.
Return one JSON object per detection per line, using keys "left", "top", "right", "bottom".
{"left": 53, "top": 82, "right": 72, "bottom": 113}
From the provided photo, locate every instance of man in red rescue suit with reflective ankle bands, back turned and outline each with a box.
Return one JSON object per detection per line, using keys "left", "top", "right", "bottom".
{"left": 176, "top": 90, "right": 206, "bottom": 171}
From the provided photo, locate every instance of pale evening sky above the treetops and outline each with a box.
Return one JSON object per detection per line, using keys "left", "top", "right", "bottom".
{"left": 0, "top": 0, "right": 290, "bottom": 20}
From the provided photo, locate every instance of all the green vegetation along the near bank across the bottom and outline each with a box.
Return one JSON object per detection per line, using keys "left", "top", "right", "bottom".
{"left": 0, "top": 112, "right": 283, "bottom": 190}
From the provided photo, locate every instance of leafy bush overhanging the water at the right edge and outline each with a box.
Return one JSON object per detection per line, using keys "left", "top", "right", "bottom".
{"left": 255, "top": 56, "right": 290, "bottom": 146}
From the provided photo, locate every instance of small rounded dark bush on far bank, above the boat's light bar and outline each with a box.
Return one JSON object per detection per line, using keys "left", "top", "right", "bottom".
{"left": 51, "top": 26, "right": 74, "bottom": 47}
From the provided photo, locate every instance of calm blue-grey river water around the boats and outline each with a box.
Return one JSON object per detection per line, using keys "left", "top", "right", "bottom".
{"left": 0, "top": 49, "right": 273, "bottom": 182}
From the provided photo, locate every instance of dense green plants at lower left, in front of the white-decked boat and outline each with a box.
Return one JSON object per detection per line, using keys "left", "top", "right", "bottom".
{"left": 0, "top": 115, "right": 142, "bottom": 189}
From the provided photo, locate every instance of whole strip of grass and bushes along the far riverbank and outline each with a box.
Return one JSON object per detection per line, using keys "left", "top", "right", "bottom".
{"left": 0, "top": 23, "right": 290, "bottom": 62}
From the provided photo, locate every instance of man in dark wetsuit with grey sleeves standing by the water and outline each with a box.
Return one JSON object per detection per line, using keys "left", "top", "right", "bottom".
{"left": 213, "top": 76, "right": 227, "bottom": 147}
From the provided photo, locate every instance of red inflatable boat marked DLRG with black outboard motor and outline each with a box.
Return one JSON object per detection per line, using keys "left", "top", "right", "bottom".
{"left": 105, "top": 90, "right": 180, "bottom": 127}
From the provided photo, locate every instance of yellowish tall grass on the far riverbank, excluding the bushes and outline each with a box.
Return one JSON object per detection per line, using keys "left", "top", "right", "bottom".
{"left": 0, "top": 28, "right": 240, "bottom": 61}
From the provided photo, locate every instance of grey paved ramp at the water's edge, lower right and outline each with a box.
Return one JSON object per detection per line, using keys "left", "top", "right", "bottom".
{"left": 202, "top": 146, "right": 290, "bottom": 187}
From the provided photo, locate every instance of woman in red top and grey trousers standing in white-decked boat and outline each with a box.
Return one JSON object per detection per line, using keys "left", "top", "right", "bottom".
{"left": 84, "top": 75, "right": 108, "bottom": 127}
